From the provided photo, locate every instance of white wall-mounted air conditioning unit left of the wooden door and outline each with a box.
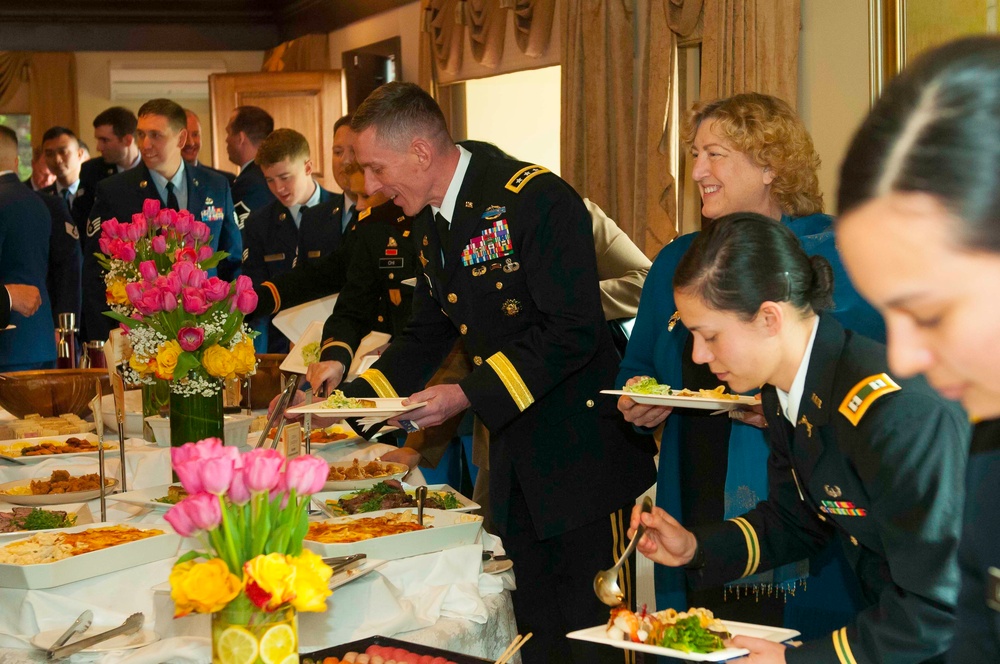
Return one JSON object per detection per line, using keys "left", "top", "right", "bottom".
{"left": 109, "top": 60, "right": 226, "bottom": 101}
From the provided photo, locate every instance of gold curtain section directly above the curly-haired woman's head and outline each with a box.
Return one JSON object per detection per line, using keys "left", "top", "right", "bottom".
{"left": 701, "top": 0, "right": 801, "bottom": 108}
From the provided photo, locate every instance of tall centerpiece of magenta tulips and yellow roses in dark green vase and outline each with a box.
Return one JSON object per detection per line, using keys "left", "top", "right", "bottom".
{"left": 96, "top": 199, "right": 257, "bottom": 445}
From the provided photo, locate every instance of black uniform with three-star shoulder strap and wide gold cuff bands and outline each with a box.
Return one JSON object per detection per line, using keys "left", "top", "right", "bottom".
{"left": 344, "top": 154, "right": 655, "bottom": 662}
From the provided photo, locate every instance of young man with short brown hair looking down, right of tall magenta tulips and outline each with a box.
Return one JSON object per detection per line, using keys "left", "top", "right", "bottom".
{"left": 243, "top": 129, "right": 343, "bottom": 353}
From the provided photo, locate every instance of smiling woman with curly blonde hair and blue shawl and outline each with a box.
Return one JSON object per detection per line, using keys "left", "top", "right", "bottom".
{"left": 616, "top": 93, "right": 885, "bottom": 637}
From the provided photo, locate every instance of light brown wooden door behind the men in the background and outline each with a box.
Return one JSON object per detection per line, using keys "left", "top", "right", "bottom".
{"left": 208, "top": 70, "right": 343, "bottom": 191}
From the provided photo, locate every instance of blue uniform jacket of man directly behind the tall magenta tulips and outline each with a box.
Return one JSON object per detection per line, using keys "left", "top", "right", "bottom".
{"left": 80, "top": 164, "right": 243, "bottom": 341}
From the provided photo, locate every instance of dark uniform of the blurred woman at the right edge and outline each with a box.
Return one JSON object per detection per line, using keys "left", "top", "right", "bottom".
{"left": 948, "top": 420, "right": 1000, "bottom": 664}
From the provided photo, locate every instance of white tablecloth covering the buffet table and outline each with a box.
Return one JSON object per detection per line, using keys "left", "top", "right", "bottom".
{"left": 0, "top": 438, "right": 517, "bottom": 664}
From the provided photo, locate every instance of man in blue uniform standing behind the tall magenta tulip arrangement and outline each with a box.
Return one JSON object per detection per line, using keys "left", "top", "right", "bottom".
{"left": 81, "top": 99, "right": 243, "bottom": 348}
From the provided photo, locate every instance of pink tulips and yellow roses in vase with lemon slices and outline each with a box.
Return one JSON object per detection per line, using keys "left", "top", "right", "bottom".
{"left": 166, "top": 438, "right": 332, "bottom": 664}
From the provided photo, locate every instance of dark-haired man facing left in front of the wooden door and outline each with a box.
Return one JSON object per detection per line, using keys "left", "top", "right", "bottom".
{"left": 226, "top": 106, "right": 274, "bottom": 229}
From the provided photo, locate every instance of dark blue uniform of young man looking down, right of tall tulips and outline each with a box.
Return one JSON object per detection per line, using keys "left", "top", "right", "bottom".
{"left": 243, "top": 185, "right": 341, "bottom": 353}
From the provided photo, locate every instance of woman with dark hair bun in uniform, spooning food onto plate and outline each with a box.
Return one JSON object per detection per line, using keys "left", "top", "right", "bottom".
{"left": 631, "top": 213, "right": 970, "bottom": 664}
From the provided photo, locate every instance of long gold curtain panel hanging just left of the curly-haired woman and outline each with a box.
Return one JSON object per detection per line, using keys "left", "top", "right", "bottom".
{"left": 561, "top": 0, "right": 700, "bottom": 257}
